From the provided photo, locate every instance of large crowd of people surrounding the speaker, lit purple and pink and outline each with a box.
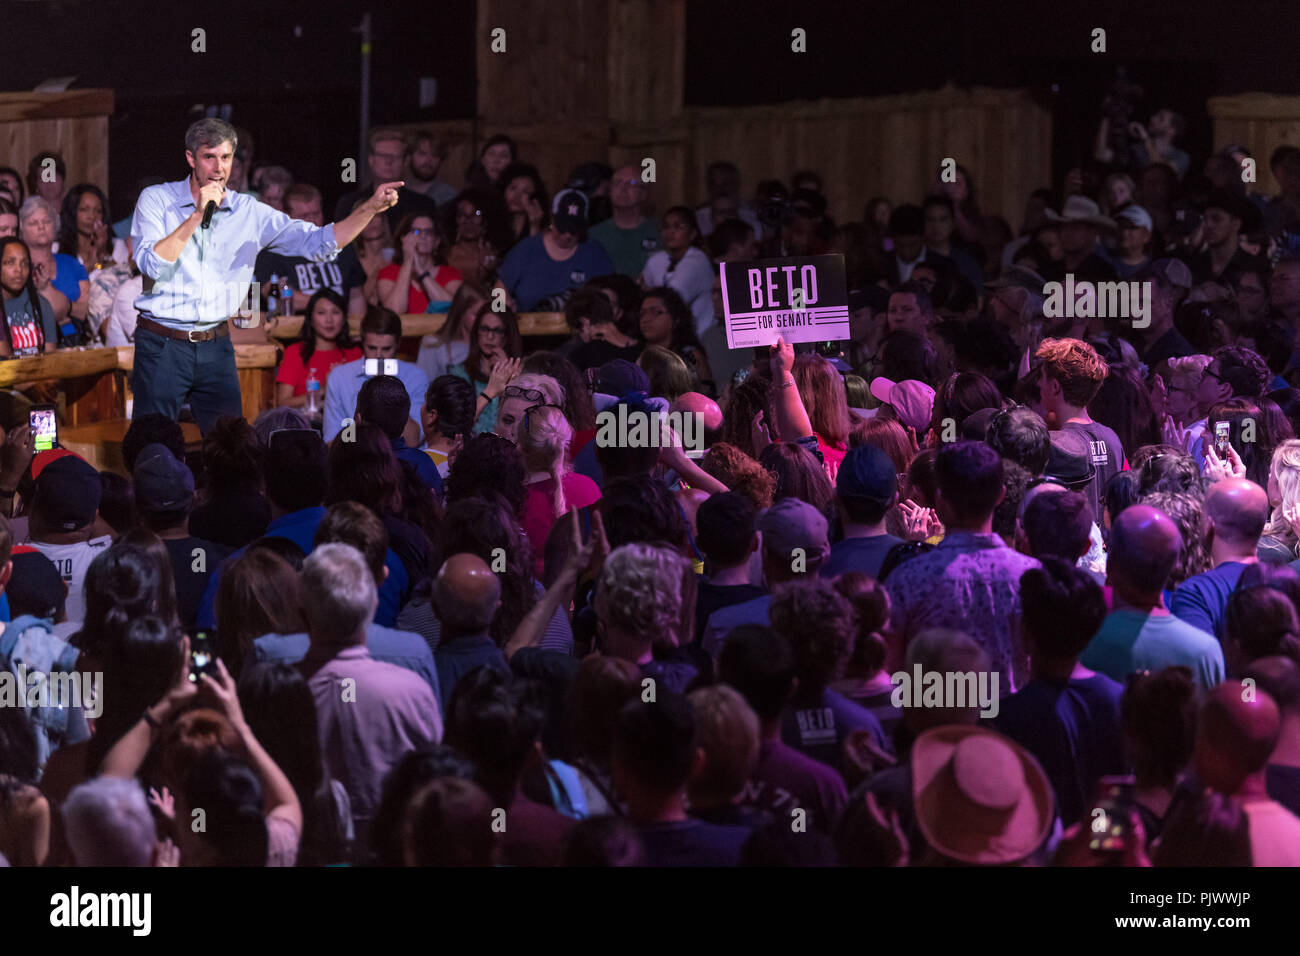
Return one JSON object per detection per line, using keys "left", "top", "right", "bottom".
{"left": 0, "top": 111, "right": 1300, "bottom": 866}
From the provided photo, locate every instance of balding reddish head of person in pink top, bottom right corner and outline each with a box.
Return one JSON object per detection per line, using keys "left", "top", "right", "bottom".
{"left": 1196, "top": 680, "right": 1282, "bottom": 793}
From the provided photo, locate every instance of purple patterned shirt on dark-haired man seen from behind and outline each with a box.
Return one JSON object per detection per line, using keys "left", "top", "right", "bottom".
{"left": 885, "top": 531, "right": 1039, "bottom": 693}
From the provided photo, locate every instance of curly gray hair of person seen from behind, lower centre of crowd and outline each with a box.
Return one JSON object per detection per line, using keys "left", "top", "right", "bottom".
{"left": 595, "top": 544, "right": 685, "bottom": 641}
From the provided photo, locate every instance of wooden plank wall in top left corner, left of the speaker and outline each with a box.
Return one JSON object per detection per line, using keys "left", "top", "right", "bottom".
{"left": 0, "top": 90, "right": 113, "bottom": 191}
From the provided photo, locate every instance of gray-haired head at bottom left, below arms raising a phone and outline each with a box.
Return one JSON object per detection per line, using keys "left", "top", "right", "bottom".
{"left": 62, "top": 777, "right": 155, "bottom": 866}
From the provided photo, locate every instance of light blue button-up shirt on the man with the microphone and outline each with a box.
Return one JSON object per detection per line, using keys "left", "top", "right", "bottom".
{"left": 131, "top": 178, "right": 340, "bottom": 327}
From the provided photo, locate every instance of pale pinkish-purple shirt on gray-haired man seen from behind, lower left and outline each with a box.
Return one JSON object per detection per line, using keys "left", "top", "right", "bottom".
{"left": 302, "top": 646, "right": 442, "bottom": 822}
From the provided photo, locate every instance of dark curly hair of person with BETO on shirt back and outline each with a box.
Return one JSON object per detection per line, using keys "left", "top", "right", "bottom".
{"left": 768, "top": 578, "right": 857, "bottom": 700}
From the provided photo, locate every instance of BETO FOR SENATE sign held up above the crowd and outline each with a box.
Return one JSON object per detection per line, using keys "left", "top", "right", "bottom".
{"left": 720, "top": 255, "right": 850, "bottom": 349}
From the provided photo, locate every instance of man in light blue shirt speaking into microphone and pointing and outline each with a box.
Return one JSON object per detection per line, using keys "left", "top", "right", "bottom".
{"left": 131, "top": 120, "right": 402, "bottom": 434}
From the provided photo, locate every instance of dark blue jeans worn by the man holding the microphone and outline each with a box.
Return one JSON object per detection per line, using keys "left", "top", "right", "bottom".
{"left": 131, "top": 329, "right": 243, "bottom": 434}
